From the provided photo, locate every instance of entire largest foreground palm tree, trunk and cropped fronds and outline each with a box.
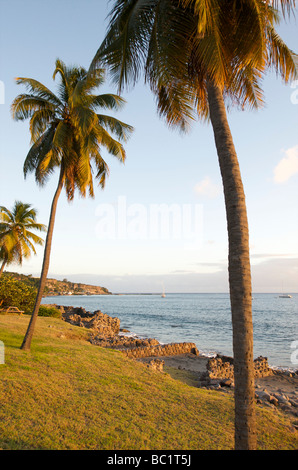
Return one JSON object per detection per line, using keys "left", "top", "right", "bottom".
{"left": 91, "top": 0, "right": 296, "bottom": 449}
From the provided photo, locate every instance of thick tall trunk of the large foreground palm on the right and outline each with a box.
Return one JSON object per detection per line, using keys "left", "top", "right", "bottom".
{"left": 208, "top": 81, "right": 256, "bottom": 450}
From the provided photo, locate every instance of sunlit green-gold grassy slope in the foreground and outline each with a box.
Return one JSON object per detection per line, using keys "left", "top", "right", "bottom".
{"left": 0, "top": 316, "right": 297, "bottom": 450}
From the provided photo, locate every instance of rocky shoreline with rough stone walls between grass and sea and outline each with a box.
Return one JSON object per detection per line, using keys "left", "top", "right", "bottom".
{"left": 48, "top": 304, "right": 298, "bottom": 422}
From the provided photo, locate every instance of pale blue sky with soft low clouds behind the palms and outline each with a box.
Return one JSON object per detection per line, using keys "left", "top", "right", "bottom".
{"left": 0, "top": 0, "right": 298, "bottom": 293}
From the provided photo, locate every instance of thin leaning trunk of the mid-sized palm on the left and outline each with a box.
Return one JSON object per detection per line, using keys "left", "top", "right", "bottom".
{"left": 21, "top": 164, "right": 64, "bottom": 351}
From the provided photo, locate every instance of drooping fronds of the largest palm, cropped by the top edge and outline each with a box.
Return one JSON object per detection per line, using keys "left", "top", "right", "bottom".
{"left": 92, "top": 0, "right": 297, "bottom": 130}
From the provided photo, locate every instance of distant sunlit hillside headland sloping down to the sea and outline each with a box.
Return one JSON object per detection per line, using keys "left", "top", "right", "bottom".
{"left": 3, "top": 272, "right": 111, "bottom": 296}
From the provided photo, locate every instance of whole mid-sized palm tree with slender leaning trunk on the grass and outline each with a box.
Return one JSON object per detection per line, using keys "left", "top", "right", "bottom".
{"left": 12, "top": 59, "right": 133, "bottom": 350}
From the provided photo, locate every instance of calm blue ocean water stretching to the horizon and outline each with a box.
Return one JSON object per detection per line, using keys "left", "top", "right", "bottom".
{"left": 43, "top": 294, "right": 298, "bottom": 370}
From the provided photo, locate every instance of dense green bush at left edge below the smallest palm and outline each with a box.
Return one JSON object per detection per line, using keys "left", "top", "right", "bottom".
{"left": 0, "top": 275, "right": 37, "bottom": 313}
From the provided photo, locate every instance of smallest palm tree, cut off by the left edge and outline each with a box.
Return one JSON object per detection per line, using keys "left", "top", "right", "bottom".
{"left": 0, "top": 201, "right": 46, "bottom": 277}
